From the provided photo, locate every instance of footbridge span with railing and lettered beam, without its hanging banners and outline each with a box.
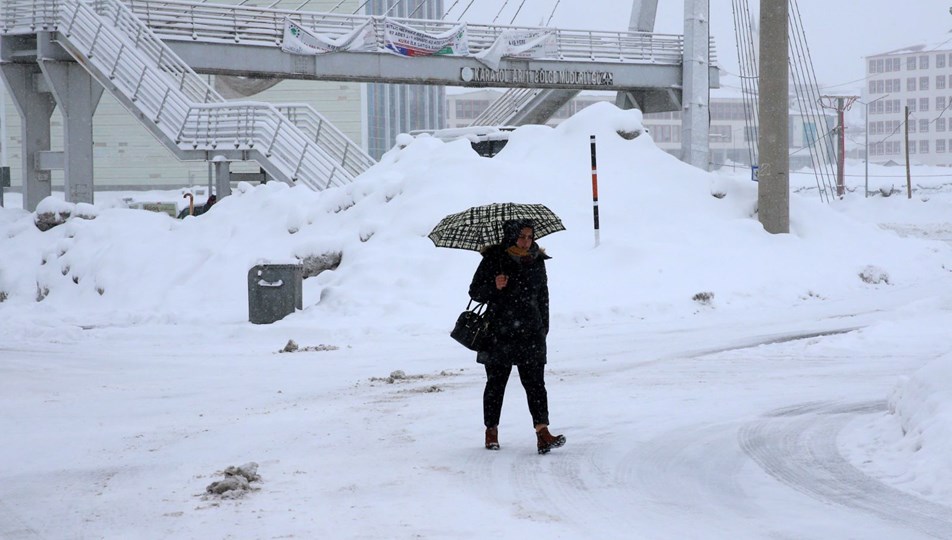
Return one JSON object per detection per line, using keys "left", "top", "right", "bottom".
{"left": 126, "top": 0, "right": 719, "bottom": 91}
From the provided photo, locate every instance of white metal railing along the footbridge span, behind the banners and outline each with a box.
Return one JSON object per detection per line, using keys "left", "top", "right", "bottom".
{"left": 117, "top": 0, "right": 716, "bottom": 65}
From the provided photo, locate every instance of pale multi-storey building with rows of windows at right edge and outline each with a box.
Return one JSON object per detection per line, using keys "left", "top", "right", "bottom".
{"left": 863, "top": 42, "right": 952, "bottom": 166}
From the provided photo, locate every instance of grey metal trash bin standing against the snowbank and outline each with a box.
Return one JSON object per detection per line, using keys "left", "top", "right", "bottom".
{"left": 248, "top": 264, "right": 304, "bottom": 324}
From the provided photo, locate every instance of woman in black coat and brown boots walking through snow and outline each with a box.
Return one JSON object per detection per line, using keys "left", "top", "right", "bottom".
{"left": 469, "top": 217, "right": 565, "bottom": 454}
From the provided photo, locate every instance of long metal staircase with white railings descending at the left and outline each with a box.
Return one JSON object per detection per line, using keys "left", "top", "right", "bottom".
{"left": 0, "top": 0, "right": 374, "bottom": 190}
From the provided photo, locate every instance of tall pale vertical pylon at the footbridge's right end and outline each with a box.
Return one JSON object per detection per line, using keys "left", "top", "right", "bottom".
{"left": 681, "top": 0, "right": 711, "bottom": 171}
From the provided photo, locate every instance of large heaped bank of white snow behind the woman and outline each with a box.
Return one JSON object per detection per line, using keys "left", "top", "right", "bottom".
{"left": 0, "top": 103, "right": 949, "bottom": 331}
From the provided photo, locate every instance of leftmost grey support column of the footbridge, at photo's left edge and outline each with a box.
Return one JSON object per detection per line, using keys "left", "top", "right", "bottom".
{"left": 0, "top": 62, "right": 56, "bottom": 212}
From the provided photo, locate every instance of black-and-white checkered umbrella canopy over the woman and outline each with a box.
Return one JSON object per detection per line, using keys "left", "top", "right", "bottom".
{"left": 428, "top": 203, "right": 565, "bottom": 251}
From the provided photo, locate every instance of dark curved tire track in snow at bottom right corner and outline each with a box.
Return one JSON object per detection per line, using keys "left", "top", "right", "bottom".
{"left": 738, "top": 401, "right": 952, "bottom": 538}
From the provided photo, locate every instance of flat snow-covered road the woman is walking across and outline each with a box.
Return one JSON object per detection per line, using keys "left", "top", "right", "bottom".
{"left": 0, "top": 311, "right": 952, "bottom": 539}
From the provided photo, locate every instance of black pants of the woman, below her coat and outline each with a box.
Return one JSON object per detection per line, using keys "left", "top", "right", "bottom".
{"left": 483, "top": 362, "right": 549, "bottom": 427}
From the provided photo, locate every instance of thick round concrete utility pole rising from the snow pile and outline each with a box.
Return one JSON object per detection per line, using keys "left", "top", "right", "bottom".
{"left": 757, "top": 0, "right": 790, "bottom": 234}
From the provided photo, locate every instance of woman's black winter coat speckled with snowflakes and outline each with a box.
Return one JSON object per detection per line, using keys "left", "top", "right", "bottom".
{"left": 469, "top": 245, "right": 550, "bottom": 365}
